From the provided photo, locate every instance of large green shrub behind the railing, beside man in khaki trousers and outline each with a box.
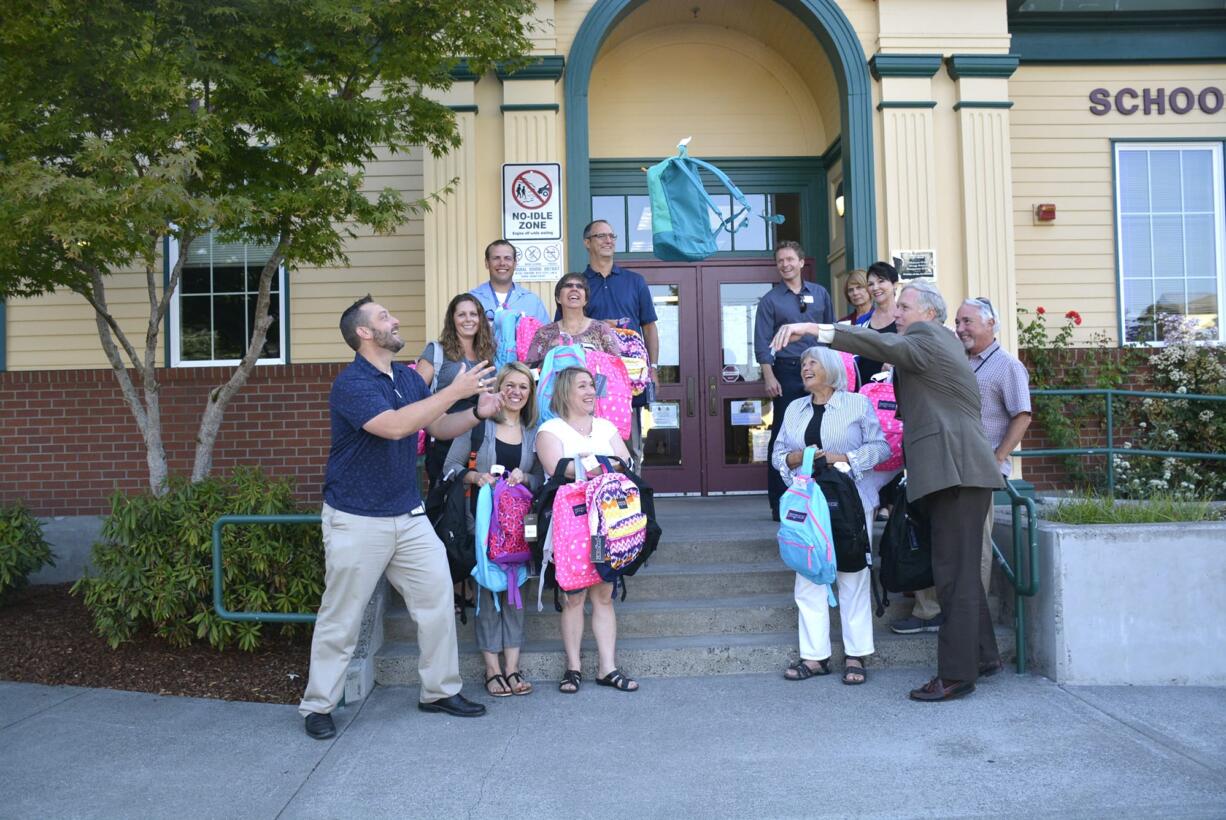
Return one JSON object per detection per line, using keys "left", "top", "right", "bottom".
{"left": 72, "top": 468, "right": 324, "bottom": 651}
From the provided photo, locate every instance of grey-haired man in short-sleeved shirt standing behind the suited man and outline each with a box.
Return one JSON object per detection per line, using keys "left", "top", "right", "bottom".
{"left": 890, "top": 298, "right": 1030, "bottom": 635}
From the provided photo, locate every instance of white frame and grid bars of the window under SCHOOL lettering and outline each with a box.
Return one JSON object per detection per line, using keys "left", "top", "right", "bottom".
{"left": 1112, "top": 140, "right": 1226, "bottom": 347}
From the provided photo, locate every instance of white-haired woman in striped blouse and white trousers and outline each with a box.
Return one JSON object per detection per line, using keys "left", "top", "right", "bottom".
{"left": 771, "top": 347, "right": 890, "bottom": 684}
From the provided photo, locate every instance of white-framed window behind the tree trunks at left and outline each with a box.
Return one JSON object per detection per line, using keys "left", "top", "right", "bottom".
{"left": 168, "top": 234, "right": 286, "bottom": 366}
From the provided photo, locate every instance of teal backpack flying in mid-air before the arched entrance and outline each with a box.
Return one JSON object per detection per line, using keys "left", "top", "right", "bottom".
{"left": 647, "top": 137, "right": 783, "bottom": 262}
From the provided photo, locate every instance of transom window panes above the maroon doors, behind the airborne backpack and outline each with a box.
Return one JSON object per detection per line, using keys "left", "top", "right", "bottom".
{"left": 592, "top": 194, "right": 801, "bottom": 254}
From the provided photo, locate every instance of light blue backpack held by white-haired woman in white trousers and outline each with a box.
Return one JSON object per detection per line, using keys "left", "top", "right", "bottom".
{"left": 779, "top": 447, "right": 839, "bottom": 607}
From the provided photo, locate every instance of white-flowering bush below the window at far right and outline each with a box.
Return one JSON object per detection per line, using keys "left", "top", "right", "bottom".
{"left": 1116, "top": 315, "right": 1226, "bottom": 499}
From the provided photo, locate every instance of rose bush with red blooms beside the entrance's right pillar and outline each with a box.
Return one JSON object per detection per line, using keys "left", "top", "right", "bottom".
{"left": 1018, "top": 306, "right": 1134, "bottom": 488}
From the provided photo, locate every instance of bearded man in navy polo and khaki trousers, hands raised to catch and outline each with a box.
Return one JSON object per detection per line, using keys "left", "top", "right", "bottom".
{"left": 298, "top": 295, "right": 501, "bottom": 740}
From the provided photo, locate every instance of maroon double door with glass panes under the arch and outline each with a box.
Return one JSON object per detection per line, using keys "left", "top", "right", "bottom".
{"left": 628, "top": 259, "right": 812, "bottom": 495}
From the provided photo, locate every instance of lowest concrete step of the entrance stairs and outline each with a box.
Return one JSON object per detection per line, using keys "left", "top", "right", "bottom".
{"left": 374, "top": 625, "right": 1014, "bottom": 688}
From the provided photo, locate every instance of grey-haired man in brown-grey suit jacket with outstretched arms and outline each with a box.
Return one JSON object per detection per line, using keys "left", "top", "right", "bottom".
{"left": 772, "top": 279, "right": 1000, "bottom": 701}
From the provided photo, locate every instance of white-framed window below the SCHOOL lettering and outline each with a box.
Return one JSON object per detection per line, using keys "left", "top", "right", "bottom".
{"left": 1116, "top": 142, "right": 1226, "bottom": 343}
